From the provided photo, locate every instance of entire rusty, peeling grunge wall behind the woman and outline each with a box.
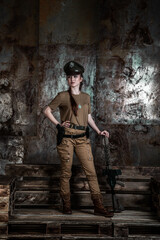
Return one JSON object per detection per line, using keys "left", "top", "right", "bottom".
{"left": 0, "top": 0, "right": 160, "bottom": 174}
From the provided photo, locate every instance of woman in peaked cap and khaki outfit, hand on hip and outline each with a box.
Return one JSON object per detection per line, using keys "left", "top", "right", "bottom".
{"left": 44, "top": 61, "right": 113, "bottom": 217}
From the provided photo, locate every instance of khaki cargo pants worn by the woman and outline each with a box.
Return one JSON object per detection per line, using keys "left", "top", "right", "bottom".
{"left": 57, "top": 128, "right": 100, "bottom": 195}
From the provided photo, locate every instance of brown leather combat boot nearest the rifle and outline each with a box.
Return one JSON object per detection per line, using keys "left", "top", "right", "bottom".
{"left": 91, "top": 194, "right": 114, "bottom": 217}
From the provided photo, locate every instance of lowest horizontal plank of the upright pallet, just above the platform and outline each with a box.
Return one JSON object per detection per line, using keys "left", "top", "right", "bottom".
{"left": 15, "top": 191, "right": 152, "bottom": 209}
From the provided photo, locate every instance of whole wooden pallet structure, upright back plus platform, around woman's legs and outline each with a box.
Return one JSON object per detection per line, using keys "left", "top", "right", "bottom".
{"left": 2, "top": 165, "right": 160, "bottom": 240}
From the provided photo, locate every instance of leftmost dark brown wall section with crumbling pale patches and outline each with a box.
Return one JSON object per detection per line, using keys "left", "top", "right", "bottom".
{"left": 0, "top": 0, "right": 39, "bottom": 174}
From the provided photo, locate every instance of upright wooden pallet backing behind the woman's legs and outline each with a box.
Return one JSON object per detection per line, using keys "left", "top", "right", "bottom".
{"left": 7, "top": 165, "right": 151, "bottom": 210}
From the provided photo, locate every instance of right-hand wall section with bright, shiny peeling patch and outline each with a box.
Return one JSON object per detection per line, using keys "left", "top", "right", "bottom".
{"left": 96, "top": 0, "right": 160, "bottom": 166}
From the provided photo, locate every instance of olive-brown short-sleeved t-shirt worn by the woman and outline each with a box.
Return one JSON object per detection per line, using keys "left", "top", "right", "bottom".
{"left": 48, "top": 91, "right": 91, "bottom": 126}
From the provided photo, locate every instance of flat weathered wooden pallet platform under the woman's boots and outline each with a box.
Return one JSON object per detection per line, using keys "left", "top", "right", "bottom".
{"left": 6, "top": 209, "right": 160, "bottom": 239}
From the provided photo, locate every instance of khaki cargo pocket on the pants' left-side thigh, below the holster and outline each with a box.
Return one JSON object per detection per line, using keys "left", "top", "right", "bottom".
{"left": 57, "top": 138, "right": 70, "bottom": 162}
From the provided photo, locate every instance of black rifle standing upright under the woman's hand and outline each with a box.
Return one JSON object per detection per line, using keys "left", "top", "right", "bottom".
{"left": 103, "top": 136, "right": 124, "bottom": 212}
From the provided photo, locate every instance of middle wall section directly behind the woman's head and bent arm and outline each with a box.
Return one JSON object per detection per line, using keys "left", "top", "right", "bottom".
{"left": 25, "top": 0, "right": 99, "bottom": 164}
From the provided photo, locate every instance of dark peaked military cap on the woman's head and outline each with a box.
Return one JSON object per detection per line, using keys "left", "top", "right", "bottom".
{"left": 63, "top": 61, "right": 84, "bottom": 75}
